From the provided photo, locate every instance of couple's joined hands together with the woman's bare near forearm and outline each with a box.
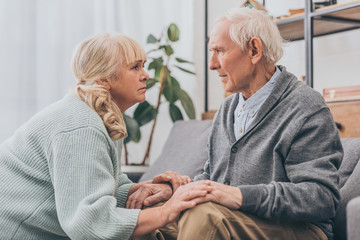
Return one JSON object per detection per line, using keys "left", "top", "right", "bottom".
{"left": 126, "top": 172, "right": 242, "bottom": 236}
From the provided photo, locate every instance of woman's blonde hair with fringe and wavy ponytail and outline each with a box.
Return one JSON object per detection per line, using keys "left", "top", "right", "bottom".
{"left": 72, "top": 33, "right": 146, "bottom": 140}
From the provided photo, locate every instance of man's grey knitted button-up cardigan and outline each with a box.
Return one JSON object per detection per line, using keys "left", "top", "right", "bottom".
{"left": 195, "top": 66, "right": 343, "bottom": 239}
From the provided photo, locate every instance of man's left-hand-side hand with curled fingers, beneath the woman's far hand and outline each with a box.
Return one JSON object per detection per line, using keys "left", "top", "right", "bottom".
{"left": 126, "top": 183, "right": 172, "bottom": 209}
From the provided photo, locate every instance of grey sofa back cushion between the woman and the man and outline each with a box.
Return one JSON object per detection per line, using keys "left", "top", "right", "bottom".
{"left": 140, "top": 120, "right": 212, "bottom": 182}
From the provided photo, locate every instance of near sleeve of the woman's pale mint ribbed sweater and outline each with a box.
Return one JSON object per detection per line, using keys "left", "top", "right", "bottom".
{"left": 49, "top": 127, "right": 140, "bottom": 239}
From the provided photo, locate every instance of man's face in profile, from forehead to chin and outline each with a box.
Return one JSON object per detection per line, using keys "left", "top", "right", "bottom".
{"left": 209, "top": 19, "right": 254, "bottom": 93}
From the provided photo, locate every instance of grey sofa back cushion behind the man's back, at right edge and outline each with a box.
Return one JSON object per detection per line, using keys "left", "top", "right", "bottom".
{"left": 334, "top": 138, "right": 360, "bottom": 240}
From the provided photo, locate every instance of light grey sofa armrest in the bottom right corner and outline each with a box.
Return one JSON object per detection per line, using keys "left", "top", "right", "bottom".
{"left": 346, "top": 196, "right": 360, "bottom": 240}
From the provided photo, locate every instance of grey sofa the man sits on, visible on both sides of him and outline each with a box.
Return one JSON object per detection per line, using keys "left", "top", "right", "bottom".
{"left": 140, "top": 120, "right": 360, "bottom": 240}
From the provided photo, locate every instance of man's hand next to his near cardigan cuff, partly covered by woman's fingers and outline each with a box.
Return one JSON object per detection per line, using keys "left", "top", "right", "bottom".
{"left": 205, "top": 181, "right": 243, "bottom": 209}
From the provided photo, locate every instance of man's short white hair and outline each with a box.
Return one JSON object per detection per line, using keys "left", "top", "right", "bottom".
{"left": 223, "top": 7, "right": 284, "bottom": 64}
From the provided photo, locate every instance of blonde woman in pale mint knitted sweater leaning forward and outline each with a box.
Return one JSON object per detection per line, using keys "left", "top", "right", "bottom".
{"left": 0, "top": 34, "right": 212, "bottom": 240}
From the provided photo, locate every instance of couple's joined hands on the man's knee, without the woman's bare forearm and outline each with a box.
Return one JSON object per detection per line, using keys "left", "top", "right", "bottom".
{"left": 126, "top": 171, "right": 243, "bottom": 212}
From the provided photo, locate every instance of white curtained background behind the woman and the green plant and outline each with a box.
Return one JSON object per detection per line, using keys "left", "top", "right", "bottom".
{"left": 0, "top": 0, "right": 197, "bottom": 166}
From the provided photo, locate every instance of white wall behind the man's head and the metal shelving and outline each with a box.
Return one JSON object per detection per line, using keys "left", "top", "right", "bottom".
{"left": 195, "top": 0, "right": 360, "bottom": 110}
